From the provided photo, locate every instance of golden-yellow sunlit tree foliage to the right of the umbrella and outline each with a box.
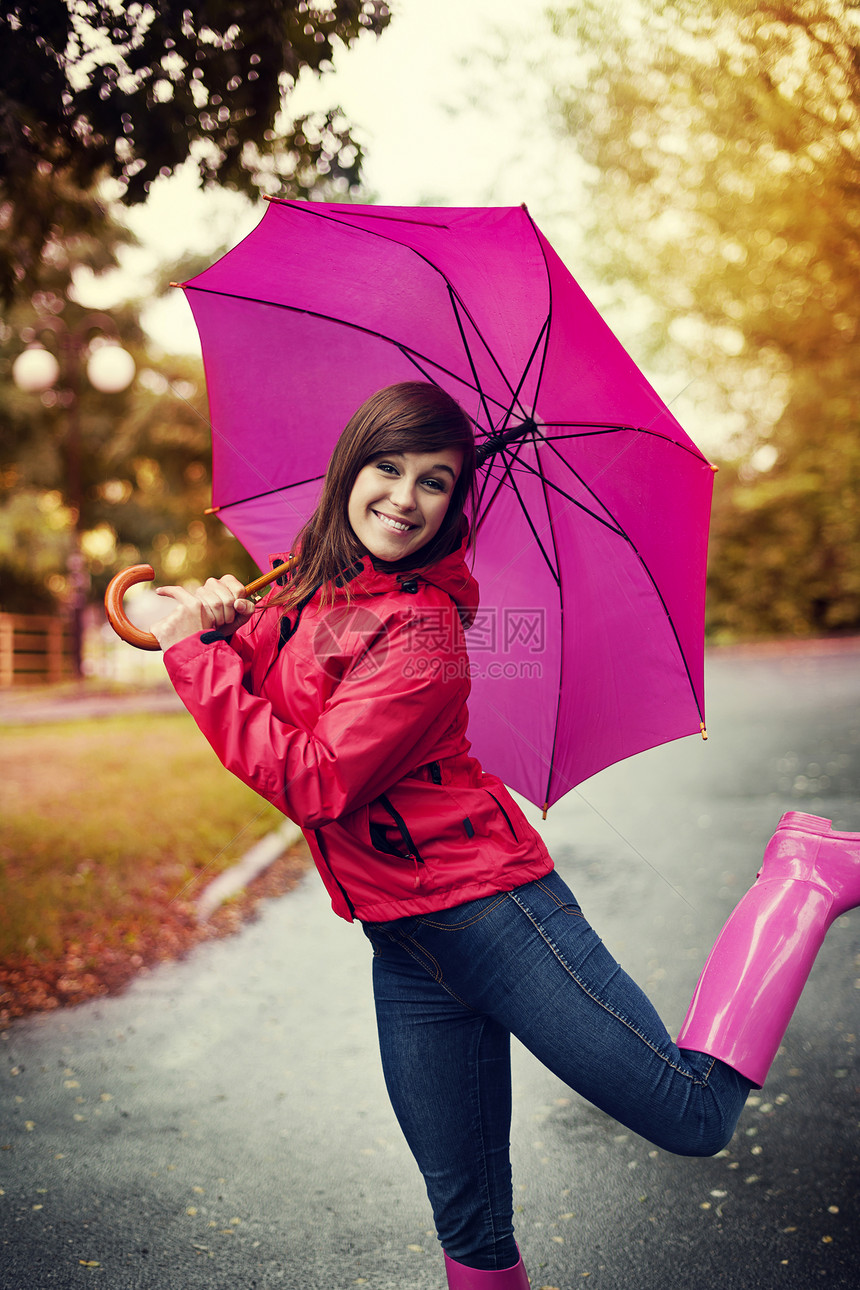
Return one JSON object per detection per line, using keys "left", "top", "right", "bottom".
{"left": 554, "top": 0, "right": 860, "bottom": 635}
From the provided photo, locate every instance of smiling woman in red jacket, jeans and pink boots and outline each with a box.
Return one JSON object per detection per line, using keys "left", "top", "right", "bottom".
{"left": 155, "top": 382, "right": 860, "bottom": 1290}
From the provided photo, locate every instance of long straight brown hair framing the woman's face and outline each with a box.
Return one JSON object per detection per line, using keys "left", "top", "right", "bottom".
{"left": 274, "top": 381, "right": 476, "bottom": 609}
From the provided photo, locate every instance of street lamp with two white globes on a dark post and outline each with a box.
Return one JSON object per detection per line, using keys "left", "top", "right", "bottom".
{"left": 12, "top": 313, "right": 134, "bottom": 677}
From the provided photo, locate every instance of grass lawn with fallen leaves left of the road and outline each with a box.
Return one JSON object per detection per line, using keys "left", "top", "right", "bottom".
{"left": 0, "top": 713, "right": 304, "bottom": 1015}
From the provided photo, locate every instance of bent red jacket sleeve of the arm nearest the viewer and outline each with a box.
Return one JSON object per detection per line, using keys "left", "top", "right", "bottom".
{"left": 164, "top": 611, "right": 469, "bottom": 828}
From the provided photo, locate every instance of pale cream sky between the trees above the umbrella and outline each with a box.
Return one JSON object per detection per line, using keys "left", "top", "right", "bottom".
{"left": 79, "top": 0, "right": 579, "bottom": 352}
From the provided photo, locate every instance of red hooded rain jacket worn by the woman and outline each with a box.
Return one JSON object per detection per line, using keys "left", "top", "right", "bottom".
{"left": 164, "top": 552, "right": 552, "bottom": 921}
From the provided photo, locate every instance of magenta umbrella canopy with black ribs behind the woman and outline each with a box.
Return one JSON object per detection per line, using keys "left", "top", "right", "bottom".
{"left": 184, "top": 201, "right": 713, "bottom": 806}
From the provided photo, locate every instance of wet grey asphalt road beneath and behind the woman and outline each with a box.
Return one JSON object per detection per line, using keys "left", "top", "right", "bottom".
{"left": 0, "top": 642, "right": 860, "bottom": 1290}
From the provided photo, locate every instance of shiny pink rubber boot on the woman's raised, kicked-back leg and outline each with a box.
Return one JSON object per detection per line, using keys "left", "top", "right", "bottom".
{"left": 678, "top": 811, "right": 860, "bottom": 1089}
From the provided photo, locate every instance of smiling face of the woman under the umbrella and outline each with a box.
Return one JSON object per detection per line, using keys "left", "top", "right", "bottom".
{"left": 347, "top": 448, "right": 463, "bottom": 564}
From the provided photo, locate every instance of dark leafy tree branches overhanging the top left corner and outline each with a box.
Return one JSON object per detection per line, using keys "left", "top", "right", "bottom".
{"left": 0, "top": 0, "right": 389, "bottom": 299}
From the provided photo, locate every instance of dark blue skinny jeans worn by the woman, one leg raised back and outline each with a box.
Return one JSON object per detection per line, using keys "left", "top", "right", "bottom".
{"left": 365, "top": 872, "right": 752, "bottom": 1271}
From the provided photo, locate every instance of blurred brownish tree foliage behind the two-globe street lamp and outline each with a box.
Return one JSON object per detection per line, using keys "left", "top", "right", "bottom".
{"left": 0, "top": 239, "right": 254, "bottom": 613}
